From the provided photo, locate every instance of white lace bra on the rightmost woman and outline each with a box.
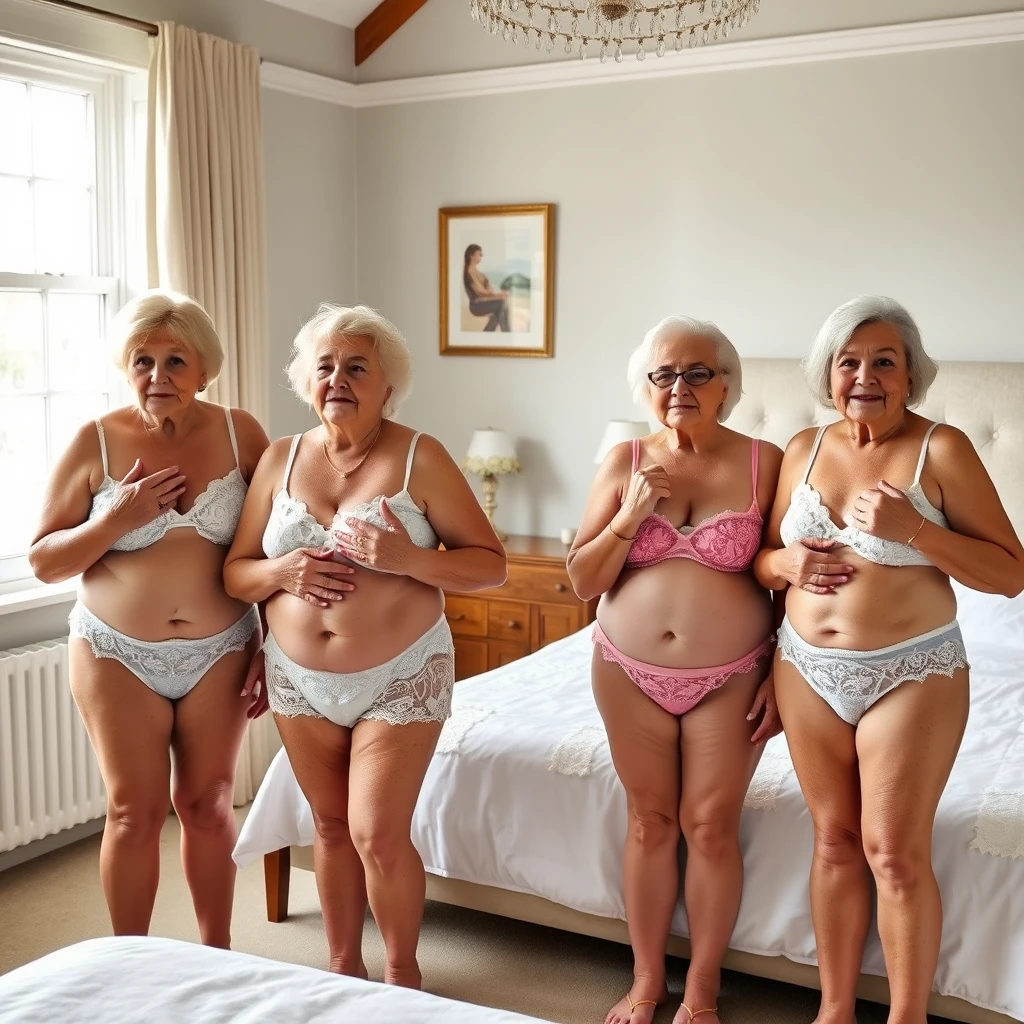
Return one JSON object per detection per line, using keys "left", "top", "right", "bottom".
{"left": 779, "top": 423, "right": 949, "bottom": 565}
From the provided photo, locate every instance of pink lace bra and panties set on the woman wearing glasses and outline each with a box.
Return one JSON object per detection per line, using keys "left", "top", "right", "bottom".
{"left": 592, "top": 439, "right": 773, "bottom": 715}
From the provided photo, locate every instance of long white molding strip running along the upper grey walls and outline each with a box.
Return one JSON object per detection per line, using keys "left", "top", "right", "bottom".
{"left": 263, "top": 10, "right": 1024, "bottom": 108}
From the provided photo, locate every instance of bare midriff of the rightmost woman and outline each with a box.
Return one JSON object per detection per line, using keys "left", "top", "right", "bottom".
{"left": 785, "top": 548, "right": 956, "bottom": 650}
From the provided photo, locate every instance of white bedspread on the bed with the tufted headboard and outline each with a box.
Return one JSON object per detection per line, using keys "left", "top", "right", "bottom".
{"left": 236, "top": 618, "right": 1024, "bottom": 1018}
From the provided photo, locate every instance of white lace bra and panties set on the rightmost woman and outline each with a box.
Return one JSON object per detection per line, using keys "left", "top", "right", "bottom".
{"left": 778, "top": 423, "right": 971, "bottom": 725}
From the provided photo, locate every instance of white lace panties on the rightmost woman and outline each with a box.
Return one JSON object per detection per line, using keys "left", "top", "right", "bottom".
{"left": 778, "top": 618, "right": 971, "bottom": 725}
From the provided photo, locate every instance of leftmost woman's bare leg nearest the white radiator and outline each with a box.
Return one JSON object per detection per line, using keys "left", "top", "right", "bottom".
{"left": 71, "top": 638, "right": 173, "bottom": 935}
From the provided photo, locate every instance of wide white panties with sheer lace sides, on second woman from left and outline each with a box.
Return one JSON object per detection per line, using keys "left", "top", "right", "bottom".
{"left": 263, "top": 615, "right": 455, "bottom": 729}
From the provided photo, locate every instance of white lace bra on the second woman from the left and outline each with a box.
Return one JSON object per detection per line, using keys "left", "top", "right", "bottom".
{"left": 263, "top": 433, "right": 437, "bottom": 571}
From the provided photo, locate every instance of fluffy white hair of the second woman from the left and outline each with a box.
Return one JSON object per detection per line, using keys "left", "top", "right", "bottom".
{"left": 287, "top": 302, "right": 413, "bottom": 418}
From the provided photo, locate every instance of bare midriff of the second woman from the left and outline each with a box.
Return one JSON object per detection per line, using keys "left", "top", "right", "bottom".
{"left": 266, "top": 568, "right": 444, "bottom": 673}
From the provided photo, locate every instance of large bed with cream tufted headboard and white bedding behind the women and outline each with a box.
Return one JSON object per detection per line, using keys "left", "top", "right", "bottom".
{"left": 236, "top": 360, "right": 1024, "bottom": 1024}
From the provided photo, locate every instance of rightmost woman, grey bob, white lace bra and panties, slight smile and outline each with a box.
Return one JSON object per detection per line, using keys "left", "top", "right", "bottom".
{"left": 756, "top": 296, "right": 1024, "bottom": 1024}
